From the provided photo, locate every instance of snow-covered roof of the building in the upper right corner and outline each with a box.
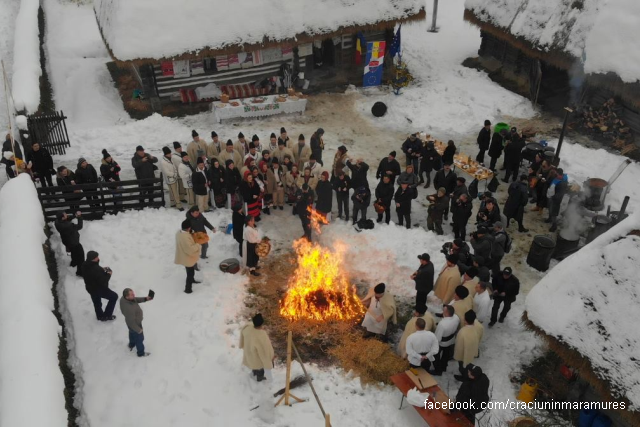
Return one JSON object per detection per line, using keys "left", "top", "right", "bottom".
{"left": 465, "top": 0, "right": 640, "bottom": 83}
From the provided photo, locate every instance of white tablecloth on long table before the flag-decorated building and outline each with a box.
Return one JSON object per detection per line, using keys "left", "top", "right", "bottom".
{"left": 211, "top": 95, "right": 307, "bottom": 123}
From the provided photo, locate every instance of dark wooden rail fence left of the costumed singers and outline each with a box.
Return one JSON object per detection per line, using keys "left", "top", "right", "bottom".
{"left": 37, "top": 176, "right": 165, "bottom": 221}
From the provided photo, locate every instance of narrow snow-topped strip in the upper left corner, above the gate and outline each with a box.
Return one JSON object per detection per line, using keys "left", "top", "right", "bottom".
{"left": 11, "top": 0, "right": 42, "bottom": 113}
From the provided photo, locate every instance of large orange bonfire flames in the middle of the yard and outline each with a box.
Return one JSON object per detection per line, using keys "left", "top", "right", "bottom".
{"left": 280, "top": 239, "right": 365, "bottom": 320}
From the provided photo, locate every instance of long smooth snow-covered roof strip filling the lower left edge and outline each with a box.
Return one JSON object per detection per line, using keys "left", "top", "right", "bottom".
{"left": 0, "top": 174, "right": 67, "bottom": 426}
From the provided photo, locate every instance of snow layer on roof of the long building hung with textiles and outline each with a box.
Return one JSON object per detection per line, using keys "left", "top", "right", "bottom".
{"left": 94, "top": 0, "right": 425, "bottom": 61}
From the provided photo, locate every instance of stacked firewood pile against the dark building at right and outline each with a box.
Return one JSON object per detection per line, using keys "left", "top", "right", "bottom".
{"left": 578, "top": 98, "right": 636, "bottom": 154}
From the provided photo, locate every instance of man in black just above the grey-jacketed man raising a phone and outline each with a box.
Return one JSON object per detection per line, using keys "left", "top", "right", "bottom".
{"left": 82, "top": 251, "right": 118, "bottom": 322}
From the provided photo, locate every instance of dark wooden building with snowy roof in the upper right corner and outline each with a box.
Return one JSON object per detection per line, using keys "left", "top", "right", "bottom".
{"left": 464, "top": 0, "right": 640, "bottom": 137}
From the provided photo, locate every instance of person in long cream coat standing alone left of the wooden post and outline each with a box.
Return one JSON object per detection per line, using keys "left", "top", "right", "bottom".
{"left": 238, "top": 313, "right": 276, "bottom": 382}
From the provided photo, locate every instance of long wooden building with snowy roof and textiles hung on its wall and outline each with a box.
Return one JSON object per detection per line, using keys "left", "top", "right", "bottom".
{"left": 94, "top": 0, "right": 426, "bottom": 117}
